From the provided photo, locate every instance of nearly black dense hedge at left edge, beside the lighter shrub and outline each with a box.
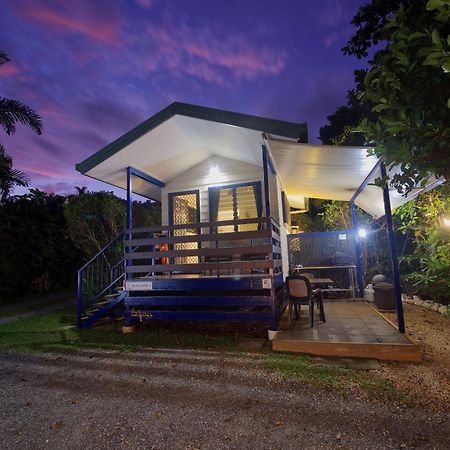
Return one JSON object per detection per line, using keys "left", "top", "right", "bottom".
{"left": 0, "top": 189, "right": 81, "bottom": 298}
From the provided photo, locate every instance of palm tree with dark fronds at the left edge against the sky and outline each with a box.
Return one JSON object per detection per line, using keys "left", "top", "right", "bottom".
{"left": 0, "top": 51, "right": 42, "bottom": 203}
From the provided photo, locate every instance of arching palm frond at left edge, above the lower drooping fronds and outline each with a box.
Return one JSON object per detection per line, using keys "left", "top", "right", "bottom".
{"left": 0, "top": 97, "right": 43, "bottom": 134}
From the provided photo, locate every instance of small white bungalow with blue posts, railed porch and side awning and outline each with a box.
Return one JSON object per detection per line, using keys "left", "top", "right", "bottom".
{"left": 76, "top": 103, "right": 442, "bottom": 331}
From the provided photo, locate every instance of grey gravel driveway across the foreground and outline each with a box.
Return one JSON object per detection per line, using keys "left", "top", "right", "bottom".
{"left": 0, "top": 349, "right": 450, "bottom": 450}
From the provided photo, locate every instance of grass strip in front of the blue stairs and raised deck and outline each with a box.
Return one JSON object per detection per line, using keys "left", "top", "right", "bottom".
{"left": 0, "top": 307, "right": 237, "bottom": 352}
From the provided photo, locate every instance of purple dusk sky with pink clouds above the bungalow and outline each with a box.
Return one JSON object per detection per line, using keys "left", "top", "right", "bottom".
{"left": 0, "top": 0, "right": 367, "bottom": 197}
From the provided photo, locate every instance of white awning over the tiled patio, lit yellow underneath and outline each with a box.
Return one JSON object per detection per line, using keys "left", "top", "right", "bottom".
{"left": 269, "top": 138, "right": 443, "bottom": 217}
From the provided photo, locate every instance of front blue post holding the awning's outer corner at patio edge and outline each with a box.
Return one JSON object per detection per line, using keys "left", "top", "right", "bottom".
{"left": 380, "top": 162, "right": 405, "bottom": 333}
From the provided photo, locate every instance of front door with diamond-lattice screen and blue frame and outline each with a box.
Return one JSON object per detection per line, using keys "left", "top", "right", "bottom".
{"left": 169, "top": 190, "right": 200, "bottom": 264}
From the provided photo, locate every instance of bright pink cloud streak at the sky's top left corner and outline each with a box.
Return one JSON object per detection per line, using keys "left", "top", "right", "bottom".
{"left": 11, "top": 1, "right": 122, "bottom": 45}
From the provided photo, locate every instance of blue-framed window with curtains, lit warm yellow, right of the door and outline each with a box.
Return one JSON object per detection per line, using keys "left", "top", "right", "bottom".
{"left": 209, "top": 182, "right": 262, "bottom": 233}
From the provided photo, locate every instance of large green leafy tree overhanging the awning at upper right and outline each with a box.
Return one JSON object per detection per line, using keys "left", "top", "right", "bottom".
{"left": 344, "top": 0, "right": 450, "bottom": 193}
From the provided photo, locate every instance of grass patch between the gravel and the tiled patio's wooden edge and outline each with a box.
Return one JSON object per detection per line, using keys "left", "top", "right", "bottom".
{"left": 263, "top": 353, "right": 407, "bottom": 403}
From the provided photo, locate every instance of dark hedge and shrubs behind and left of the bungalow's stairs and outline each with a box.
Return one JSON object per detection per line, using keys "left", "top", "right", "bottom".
{"left": 0, "top": 188, "right": 161, "bottom": 300}
